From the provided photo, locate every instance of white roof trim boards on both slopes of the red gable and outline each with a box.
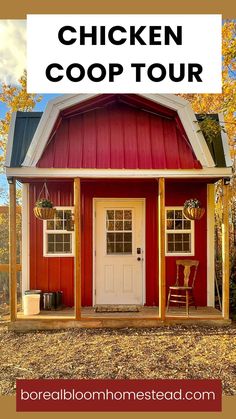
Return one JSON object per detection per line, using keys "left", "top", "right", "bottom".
{"left": 22, "top": 94, "right": 215, "bottom": 167}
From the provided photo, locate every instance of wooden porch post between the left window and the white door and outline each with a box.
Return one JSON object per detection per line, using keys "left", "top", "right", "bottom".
{"left": 74, "top": 178, "right": 81, "bottom": 320}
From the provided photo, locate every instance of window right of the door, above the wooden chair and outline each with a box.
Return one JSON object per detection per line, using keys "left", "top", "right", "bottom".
{"left": 166, "top": 207, "right": 194, "bottom": 256}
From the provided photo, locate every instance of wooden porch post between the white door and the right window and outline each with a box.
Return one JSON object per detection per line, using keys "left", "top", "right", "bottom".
{"left": 158, "top": 178, "right": 166, "bottom": 320}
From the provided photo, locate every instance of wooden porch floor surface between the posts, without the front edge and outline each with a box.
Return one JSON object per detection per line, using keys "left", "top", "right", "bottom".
{"left": 17, "top": 307, "right": 222, "bottom": 320}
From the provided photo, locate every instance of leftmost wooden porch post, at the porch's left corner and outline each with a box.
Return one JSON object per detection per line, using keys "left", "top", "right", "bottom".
{"left": 9, "top": 178, "right": 17, "bottom": 322}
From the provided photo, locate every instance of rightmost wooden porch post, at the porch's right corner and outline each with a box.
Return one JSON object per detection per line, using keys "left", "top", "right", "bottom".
{"left": 222, "top": 183, "right": 229, "bottom": 320}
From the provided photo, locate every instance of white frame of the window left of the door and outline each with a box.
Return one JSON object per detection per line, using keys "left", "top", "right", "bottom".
{"left": 43, "top": 206, "right": 75, "bottom": 258}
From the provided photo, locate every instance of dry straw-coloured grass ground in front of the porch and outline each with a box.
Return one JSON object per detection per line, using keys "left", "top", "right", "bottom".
{"left": 0, "top": 324, "right": 236, "bottom": 395}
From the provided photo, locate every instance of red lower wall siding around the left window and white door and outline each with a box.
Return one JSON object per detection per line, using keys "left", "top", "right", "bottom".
{"left": 30, "top": 181, "right": 158, "bottom": 306}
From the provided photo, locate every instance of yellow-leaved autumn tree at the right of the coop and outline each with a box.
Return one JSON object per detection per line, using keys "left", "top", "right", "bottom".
{"left": 181, "top": 20, "right": 236, "bottom": 313}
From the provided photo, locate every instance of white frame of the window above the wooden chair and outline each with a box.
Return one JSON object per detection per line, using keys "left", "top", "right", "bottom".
{"left": 165, "top": 206, "right": 195, "bottom": 256}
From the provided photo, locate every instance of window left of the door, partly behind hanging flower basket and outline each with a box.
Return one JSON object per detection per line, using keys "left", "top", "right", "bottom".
{"left": 43, "top": 207, "right": 74, "bottom": 257}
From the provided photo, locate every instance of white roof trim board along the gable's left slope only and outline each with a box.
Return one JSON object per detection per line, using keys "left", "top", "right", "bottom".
{"left": 22, "top": 94, "right": 97, "bottom": 166}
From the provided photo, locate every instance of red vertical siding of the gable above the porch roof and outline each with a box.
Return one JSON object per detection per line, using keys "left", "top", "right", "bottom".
{"left": 37, "top": 102, "right": 201, "bottom": 169}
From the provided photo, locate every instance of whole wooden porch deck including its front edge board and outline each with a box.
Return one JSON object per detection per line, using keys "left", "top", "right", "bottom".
{"left": 8, "top": 307, "right": 230, "bottom": 332}
